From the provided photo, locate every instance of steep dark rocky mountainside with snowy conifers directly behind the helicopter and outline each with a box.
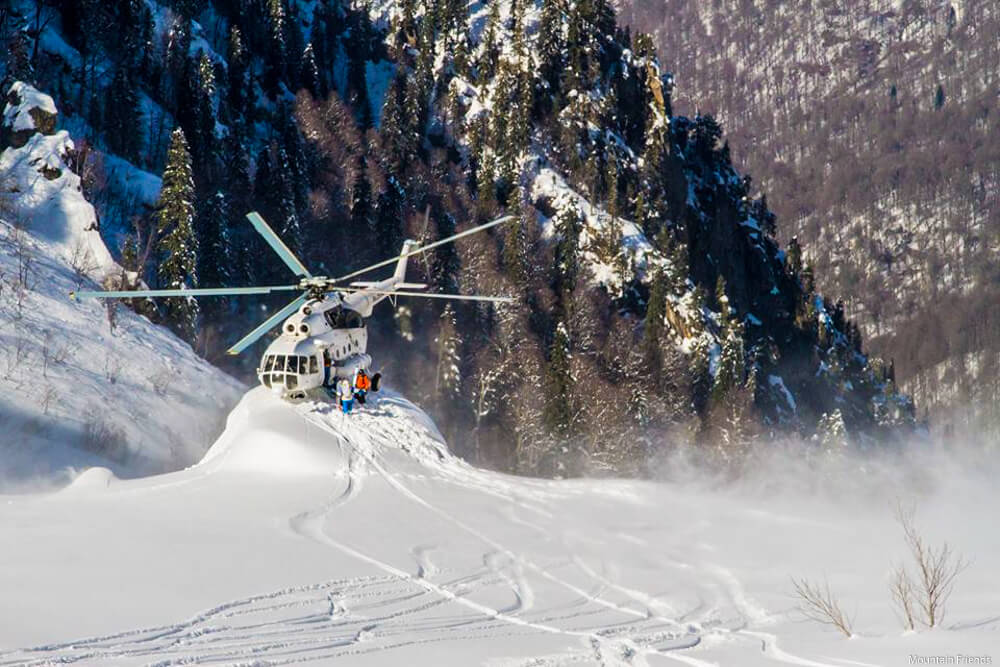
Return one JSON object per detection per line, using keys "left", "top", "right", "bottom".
{"left": 6, "top": 0, "right": 916, "bottom": 476}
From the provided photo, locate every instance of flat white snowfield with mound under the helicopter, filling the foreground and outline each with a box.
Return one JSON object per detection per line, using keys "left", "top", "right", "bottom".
{"left": 0, "top": 388, "right": 1000, "bottom": 667}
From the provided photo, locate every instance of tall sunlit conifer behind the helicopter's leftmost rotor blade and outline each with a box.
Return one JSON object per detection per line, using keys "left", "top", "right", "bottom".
{"left": 156, "top": 128, "right": 198, "bottom": 343}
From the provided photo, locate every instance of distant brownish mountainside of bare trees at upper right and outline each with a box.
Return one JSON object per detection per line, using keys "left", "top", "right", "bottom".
{"left": 617, "top": 0, "right": 1000, "bottom": 439}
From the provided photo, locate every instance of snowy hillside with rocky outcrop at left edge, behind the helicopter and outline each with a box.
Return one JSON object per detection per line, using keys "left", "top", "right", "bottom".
{"left": 0, "top": 83, "right": 242, "bottom": 490}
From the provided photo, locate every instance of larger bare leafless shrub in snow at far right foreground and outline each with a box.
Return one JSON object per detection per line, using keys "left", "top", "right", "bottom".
{"left": 891, "top": 503, "right": 969, "bottom": 628}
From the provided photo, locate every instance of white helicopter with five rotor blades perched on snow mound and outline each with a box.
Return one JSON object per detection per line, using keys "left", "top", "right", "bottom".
{"left": 70, "top": 211, "right": 513, "bottom": 400}
